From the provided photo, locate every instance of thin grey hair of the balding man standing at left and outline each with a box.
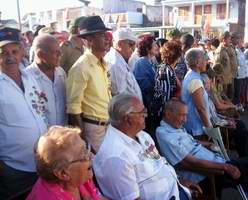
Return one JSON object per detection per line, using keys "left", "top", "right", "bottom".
{"left": 32, "top": 34, "right": 58, "bottom": 55}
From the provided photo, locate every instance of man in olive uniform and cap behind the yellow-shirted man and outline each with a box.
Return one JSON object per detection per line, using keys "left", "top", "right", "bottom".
{"left": 60, "top": 17, "right": 85, "bottom": 73}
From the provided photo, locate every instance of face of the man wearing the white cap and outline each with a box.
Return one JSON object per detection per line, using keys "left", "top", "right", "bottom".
{"left": 118, "top": 40, "right": 135, "bottom": 61}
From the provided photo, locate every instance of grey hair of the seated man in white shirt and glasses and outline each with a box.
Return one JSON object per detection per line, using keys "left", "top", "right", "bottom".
{"left": 108, "top": 93, "right": 138, "bottom": 125}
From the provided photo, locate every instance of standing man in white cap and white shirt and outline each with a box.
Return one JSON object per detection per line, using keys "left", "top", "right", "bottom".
{"left": 105, "top": 28, "right": 142, "bottom": 100}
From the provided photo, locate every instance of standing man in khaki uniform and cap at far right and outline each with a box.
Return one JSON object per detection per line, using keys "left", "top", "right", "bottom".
{"left": 214, "top": 31, "right": 237, "bottom": 99}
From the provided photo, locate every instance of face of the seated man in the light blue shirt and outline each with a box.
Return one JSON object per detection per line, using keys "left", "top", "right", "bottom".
{"left": 166, "top": 105, "right": 188, "bottom": 129}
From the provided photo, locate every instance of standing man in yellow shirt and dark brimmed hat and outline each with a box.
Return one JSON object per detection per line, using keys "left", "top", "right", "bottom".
{"left": 66, "top": 16, "right": 111, "bottom": 152}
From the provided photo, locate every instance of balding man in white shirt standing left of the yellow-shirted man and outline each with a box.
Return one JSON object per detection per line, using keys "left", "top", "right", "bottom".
{"left": 26, "top": 34, "right": 66, "bottom": 126}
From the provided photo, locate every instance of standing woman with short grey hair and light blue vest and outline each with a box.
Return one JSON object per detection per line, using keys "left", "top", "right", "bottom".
{"left": 182, "top": 48, "right": 212, "bottom": 136}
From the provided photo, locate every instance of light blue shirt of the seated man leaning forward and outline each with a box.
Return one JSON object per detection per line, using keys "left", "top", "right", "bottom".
{"left": 156, "top": 120, "right": 226, "bottom": 183}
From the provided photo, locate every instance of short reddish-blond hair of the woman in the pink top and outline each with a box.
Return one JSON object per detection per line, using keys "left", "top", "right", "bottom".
{"left": 34, "top": 126, "right": 89, "bottom": 182}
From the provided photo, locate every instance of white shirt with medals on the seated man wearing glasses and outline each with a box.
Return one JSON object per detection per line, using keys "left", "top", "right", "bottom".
{"left": 93, "top": 125, "right": 187, "bottom": 200}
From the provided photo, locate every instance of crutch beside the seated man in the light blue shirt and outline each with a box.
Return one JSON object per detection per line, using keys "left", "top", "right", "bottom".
{"left": 203, "top": 127, "right": 248, "bottom": 200}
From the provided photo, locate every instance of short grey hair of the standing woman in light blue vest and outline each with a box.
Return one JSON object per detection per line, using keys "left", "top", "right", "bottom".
{"left": 185, "top": 48, "right": 204, "bottom": 69}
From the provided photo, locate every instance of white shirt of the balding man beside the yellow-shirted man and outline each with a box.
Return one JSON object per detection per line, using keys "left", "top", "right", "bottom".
{"left": 26, "top": 62, "right": 66, "bottom": 126}
